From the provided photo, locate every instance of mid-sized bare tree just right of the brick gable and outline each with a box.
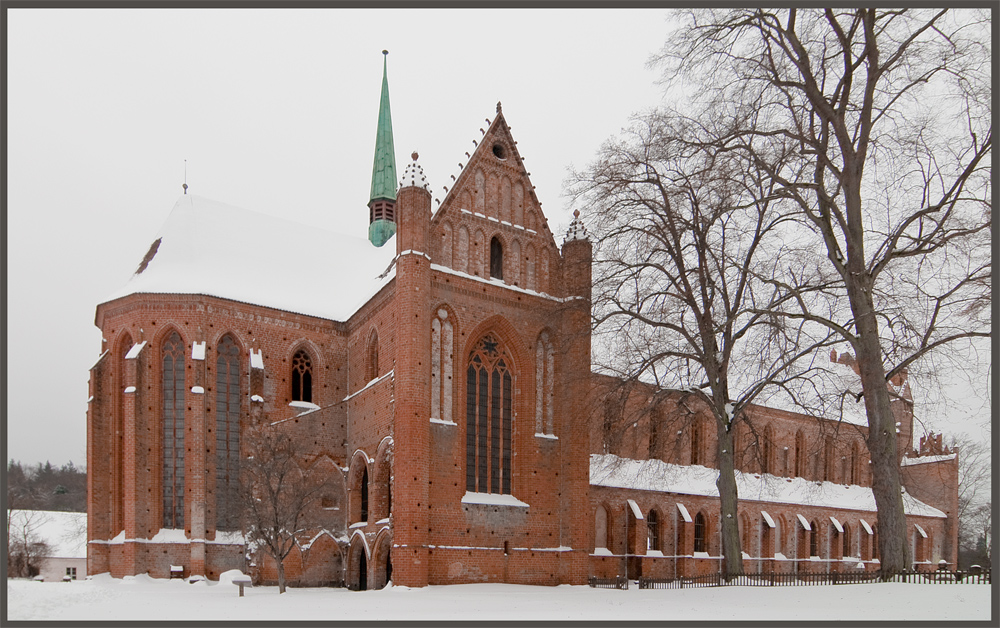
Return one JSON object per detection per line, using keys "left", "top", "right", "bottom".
{"left": 570, "top": 111, "right": 831, "bottom": 577}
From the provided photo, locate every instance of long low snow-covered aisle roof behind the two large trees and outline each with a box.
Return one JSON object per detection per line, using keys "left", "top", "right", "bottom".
{"left": 590, "top": 454, "right": 946, "bottom": 518}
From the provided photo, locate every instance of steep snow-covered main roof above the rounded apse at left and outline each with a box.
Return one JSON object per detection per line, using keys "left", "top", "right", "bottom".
{"left": 106, "top": 195, "right": 396, "bottom": 321}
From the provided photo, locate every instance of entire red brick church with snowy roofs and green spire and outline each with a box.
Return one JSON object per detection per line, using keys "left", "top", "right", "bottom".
{"left": 87, "top": 54, "right": 958, "bottom": 589}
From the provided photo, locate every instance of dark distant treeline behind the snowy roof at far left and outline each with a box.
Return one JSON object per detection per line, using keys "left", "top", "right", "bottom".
{"left": 7, "top": 460, "right": 87, "bottom": 512}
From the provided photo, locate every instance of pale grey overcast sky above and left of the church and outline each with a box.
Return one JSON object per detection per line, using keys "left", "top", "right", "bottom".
{"left": 5, "top": 9, "right": 988, "bottom": 465}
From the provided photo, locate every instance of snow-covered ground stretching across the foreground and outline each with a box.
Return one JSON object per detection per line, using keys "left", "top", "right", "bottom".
{"left": 6, "top": 574, "right": 992, "bottom": 623}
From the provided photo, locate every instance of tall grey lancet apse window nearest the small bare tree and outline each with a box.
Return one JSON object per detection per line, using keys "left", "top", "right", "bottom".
{"left": 215, "top": 335, "right": 242, "bottom": 530}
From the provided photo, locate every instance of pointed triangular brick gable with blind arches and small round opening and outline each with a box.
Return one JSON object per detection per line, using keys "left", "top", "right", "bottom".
{"left": 431, "top": 103, "right": 559, "bottom": 291}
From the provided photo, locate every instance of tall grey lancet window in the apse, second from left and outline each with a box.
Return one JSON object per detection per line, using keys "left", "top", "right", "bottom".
{"left": 161, "top": 332, "right": 184, "bottom": 528}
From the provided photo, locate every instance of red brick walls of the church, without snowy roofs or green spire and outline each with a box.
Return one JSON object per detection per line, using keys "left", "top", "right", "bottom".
{"left": 87, "top": 107, "right": 956, "bottom": 588}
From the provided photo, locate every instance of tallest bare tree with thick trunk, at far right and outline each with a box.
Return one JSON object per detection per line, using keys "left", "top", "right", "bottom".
{"left": 659, "top": 8, "right": 992, "bottom": 574}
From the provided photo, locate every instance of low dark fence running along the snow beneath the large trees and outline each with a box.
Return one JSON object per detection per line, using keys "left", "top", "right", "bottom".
{"left": 590, "top": 571, "right": 993, "bottom": 589}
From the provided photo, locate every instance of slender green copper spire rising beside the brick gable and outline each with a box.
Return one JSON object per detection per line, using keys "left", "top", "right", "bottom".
{"left": 368, "top": 50, "right": 396, "bottom": 246}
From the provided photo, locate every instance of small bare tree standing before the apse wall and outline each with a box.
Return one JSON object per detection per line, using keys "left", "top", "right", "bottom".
{"left": 239, "top": 421, "right": 329, "bottom": 593}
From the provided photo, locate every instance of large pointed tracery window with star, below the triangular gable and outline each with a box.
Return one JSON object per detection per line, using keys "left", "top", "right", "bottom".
{"left": 465, "top": 334, "right": 514, "bottom": 495}
